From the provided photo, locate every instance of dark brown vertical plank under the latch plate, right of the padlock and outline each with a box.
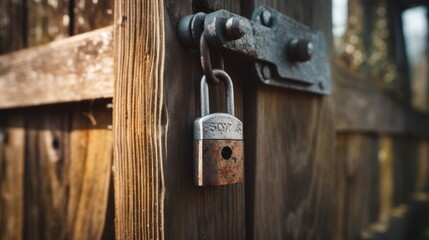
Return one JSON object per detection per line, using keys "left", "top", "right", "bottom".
{"left": 242, "top": 0, "right": 343, "bottom": 239}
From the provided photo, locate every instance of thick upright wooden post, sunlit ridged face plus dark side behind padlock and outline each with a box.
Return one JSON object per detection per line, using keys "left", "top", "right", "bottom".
{"left": 113, "top": 0, "right": 244, "bottom": 239}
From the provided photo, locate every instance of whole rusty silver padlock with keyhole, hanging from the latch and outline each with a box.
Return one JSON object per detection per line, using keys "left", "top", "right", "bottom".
{"left": 194, "top": 69, "right": 244, "bottom": 186}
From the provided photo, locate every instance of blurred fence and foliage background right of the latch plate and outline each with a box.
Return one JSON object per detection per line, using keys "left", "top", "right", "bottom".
{"left": 332, "top": 0, "right": 429, "bottom": 239}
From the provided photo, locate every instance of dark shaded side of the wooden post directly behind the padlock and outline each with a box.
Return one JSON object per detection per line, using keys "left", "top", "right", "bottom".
{"left": 164, "top": 0, "right": 247, "bottom": 239}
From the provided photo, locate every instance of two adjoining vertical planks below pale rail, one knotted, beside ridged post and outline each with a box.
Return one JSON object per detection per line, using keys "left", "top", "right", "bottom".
{"left": 20, "top": 103, "right": 113, "bottom": 239}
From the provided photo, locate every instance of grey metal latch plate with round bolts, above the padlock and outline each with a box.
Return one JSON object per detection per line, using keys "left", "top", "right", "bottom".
{"left": 178, "top": 6, "right": 332, "bottom": 95}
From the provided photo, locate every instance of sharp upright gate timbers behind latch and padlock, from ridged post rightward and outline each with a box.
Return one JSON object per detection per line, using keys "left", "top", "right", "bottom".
{"left": 114, "top": 0, "right": 341, "bottom": 239}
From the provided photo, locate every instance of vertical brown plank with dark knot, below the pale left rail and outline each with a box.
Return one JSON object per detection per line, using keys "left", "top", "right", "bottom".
{"left": 24, "top": 106, "right": 70, "bottom": 239}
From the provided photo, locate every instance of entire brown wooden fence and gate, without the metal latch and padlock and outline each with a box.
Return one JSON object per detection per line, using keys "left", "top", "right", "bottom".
{"left": 0, "top": 0, "right": 429, "bottom": 240}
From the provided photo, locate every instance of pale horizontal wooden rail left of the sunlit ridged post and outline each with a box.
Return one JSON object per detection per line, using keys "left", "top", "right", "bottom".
{"left": 0, "top": 27, "right": 113, "bottom": 108}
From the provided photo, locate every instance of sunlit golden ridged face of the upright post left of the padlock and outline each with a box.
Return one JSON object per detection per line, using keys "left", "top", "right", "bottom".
{"left": 113, "top": 0, "right": 167, "bottom": 239}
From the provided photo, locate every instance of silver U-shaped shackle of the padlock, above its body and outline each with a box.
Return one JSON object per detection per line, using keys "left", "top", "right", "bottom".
{"left": 200, "top": 69, "right": 235, "bottom": 117}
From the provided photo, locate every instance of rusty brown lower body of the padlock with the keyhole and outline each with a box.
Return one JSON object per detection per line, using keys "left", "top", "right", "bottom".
{"left": 194, "top": 140, "right": 244, "bottom": 186}
